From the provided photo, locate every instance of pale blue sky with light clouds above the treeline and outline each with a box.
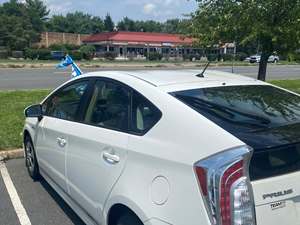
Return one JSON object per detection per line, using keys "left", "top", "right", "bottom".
{"left": 0, "top": 0, "right": 197, "bottom": 21}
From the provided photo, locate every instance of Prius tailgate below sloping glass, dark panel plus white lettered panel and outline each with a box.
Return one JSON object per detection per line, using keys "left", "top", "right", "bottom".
{"left": 246, "top": 124, "right": 300, "bottom": 225}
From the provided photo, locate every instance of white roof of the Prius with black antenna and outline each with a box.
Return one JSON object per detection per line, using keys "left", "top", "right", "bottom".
{"left": 81, "top": 68, "right": 264, "bottom": 91}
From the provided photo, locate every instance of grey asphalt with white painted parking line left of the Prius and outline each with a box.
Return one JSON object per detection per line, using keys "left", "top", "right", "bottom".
{"left": 0, "top": 159, "right": 84, "bottom": 225}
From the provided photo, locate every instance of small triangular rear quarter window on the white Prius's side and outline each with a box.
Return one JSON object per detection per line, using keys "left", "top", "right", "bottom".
{"left": 131, "top": 91, "right": 161, "bottom": 134}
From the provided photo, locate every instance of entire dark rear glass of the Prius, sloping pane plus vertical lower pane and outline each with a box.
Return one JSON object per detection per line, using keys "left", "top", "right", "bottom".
{"left": 172, "top": 85, "right": 300, "bottom": 180}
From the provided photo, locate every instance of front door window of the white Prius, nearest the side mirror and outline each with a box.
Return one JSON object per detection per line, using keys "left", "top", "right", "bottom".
{"left": 43, "top": 81, "right": 89, "bottom": 121}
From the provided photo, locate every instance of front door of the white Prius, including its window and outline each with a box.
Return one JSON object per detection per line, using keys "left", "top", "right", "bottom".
{"left": 36, "top": 80, "right": 89, "bottom": 191}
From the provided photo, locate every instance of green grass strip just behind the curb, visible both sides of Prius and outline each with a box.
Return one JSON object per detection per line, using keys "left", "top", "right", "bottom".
{"left": 0, "top": 80, "right": 300, "bottom": 150}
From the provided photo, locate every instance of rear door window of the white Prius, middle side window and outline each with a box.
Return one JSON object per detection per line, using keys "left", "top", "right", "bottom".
{"left": 84, "top": 81, "right": 130, "bottom": 131}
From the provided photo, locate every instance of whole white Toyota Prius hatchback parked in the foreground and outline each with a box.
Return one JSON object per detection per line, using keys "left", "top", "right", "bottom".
{"left": 24, "top": 70, "right": 300, "bottom": 225}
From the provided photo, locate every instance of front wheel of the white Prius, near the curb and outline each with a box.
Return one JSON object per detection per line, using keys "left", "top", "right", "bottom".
{"left": 24, "top": 136, "right": 40, "bottom": 181}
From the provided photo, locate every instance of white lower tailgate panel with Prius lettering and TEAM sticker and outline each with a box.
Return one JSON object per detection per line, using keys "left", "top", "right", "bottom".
{"left": 252, "top": 172, "right": 300, "bottom": 225}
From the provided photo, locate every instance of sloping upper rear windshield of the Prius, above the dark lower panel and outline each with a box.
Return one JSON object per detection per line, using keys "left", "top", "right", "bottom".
{"left": 173, "top": 85, "right": 300, "bottom": 133}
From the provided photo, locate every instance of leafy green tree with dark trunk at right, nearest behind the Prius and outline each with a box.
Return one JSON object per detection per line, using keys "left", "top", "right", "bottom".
{"left": 192, "top": 0, "right": 300, "bottom": 80}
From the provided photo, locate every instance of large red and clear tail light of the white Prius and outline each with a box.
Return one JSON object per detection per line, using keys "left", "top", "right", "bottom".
{"left": 195, "top": 146, "right": 256, "bottom": 225}
